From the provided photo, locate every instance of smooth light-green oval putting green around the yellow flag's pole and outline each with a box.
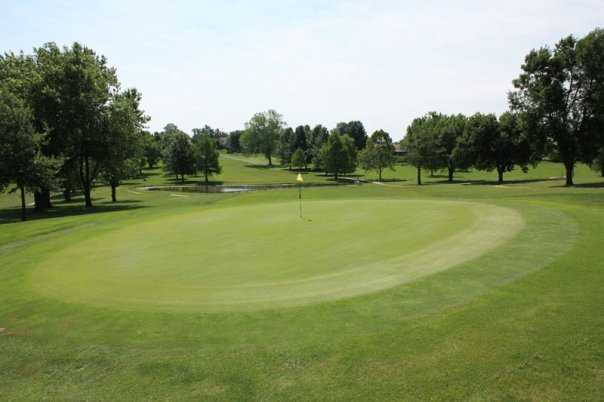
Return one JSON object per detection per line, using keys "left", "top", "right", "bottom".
{"left": 31, "top": 200, "right": 523, "bottom": 312}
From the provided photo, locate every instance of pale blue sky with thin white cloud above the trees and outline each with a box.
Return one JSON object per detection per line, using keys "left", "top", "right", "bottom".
{"left": 0, "top": 0, "right": 604, "bottom": 139}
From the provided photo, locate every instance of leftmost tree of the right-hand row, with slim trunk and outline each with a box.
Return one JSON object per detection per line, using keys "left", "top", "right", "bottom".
{"left": 402, "top": 112, "right": 444, "bottom": 185}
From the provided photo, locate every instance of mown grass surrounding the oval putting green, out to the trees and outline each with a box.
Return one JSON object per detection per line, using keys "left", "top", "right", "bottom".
{"left": 0, "top": 154, "right": 604, "bottom": 401}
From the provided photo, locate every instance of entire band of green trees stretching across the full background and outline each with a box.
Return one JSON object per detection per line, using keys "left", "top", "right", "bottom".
{"left": 0, "top": 29, "right": 604, "bottom": 219}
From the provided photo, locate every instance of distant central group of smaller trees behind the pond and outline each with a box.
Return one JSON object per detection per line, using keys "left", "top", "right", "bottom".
{"left": 151, "top": 110, "right": 395, "bottom": 184}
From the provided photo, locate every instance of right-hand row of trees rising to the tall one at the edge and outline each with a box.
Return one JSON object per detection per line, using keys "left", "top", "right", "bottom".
{"left": 402, "top": 29, "right": 604, "bottom": 186}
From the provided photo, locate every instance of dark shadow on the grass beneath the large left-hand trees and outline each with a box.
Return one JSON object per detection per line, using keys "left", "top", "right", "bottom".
{"left": 0, "top": 200, "right": 145, "bottom": 225}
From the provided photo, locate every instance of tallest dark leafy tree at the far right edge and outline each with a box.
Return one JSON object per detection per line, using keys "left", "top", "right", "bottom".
{"left": 509, "top": 29, "right": 604, "bottom": 186}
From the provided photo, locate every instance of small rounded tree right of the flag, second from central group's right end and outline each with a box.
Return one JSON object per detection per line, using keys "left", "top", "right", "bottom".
{"left": 321, "top": 131, "right": 357, "bottom": 181}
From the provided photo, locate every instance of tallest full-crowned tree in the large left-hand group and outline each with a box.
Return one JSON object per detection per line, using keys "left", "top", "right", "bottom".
{"left": 32, "top": 43, "right": 118, "bottom": 207}
